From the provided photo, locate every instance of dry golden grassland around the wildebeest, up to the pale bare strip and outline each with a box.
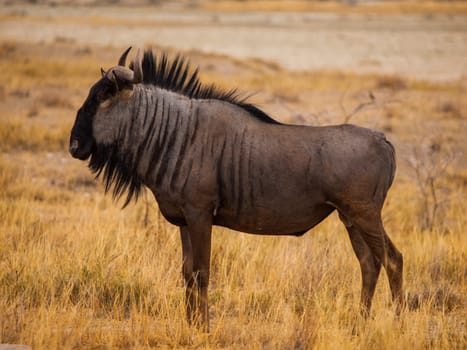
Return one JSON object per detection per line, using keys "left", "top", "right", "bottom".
{"left": 0, "top": 2, "right": 467, "bottom": 349}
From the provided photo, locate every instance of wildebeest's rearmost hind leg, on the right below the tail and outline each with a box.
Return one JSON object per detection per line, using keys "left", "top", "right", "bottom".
{"left": 342, "top": 210, "right": 403, "bottom": 314}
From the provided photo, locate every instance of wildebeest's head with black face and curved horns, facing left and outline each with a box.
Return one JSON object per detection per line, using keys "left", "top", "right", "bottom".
{"left": 70, "top": 47, "right": 142, "bottom": 160}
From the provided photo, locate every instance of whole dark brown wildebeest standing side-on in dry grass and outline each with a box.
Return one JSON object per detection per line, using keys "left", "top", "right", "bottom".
{"left": 70, "top": 48, "right": 402, "bottom": 328}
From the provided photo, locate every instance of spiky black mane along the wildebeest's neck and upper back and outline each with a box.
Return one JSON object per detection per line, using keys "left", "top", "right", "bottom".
{"left": 142, "top": 50, "right": 280, "bottom": 124}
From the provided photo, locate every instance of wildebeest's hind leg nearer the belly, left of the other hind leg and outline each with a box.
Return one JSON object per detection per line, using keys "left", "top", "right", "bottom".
{"left": 340, "top": 216, "right": 381, "bottom": 317}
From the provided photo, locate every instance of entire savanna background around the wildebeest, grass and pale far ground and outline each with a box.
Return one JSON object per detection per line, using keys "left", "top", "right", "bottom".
{"left": 0, "top": 0, "right": 467, "bottom": 349}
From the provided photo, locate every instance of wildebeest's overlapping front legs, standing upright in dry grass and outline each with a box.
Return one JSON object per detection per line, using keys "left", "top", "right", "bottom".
{"left": 180, "top": 210, "right": 212, "bottom": 331}
